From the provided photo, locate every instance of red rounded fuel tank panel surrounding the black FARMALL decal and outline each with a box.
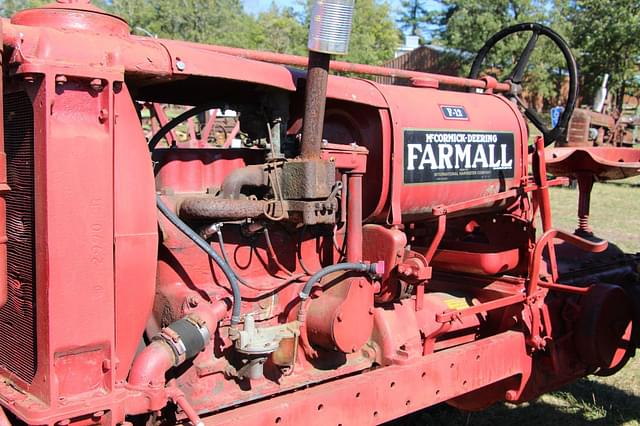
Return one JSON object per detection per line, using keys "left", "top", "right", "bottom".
{"left": 381, "top": 86, "right": 527, "bottom": 223}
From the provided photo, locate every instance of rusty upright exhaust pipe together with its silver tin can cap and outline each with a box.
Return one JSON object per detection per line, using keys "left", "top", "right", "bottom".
{"left": 300, "top": 0, "right": 355, "bottom": 159}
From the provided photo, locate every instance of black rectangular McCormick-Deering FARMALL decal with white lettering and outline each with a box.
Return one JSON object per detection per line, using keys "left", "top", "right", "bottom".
{"left": 404, "top": 130, "right": 514, "bottom": 184}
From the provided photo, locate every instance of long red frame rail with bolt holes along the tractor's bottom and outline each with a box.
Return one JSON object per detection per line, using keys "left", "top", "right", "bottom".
{"left": 203, "top": 332, "right": 531, "bottom": 425}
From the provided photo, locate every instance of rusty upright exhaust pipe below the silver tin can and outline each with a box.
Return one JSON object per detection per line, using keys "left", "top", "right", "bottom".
{"left": 300, "top": 51, "right": 331, "bottom": 159}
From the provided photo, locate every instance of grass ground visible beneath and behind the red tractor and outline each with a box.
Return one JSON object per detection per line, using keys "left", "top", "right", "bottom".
{"left": 393, "top": 178, "right": 640, "bottom": 426}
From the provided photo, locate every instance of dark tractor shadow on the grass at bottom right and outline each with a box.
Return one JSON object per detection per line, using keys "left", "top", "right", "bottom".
{"left": 386, "top": 378, "right": 640, "bottom": 426}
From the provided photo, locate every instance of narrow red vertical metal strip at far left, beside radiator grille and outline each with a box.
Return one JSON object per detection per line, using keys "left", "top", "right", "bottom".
{"left": 0, "top": 19, "right": 9, "bottom": 307}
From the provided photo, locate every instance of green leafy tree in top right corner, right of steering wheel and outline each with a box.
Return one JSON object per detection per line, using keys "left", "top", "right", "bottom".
{"left": 570, "top": 0, "right": 640, "bottom": 107}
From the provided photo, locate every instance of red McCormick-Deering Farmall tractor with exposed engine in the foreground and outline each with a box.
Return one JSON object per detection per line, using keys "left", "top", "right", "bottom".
{"left": 0, "top": 0, "right": 640, "bottom": 425}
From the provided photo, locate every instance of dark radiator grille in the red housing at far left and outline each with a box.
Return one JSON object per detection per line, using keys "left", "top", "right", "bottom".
{"left": 0, "top": 92, "right": 37, "bottom": 383}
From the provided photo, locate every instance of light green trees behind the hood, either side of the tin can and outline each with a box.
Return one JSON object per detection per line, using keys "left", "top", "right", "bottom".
{"left": 1, "top": 0, "right": 400, "bottom": 64}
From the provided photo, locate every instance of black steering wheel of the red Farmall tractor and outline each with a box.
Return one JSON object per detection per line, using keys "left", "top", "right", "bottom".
{"left": 469, "top": 23, "right": 578, "bottom": 153}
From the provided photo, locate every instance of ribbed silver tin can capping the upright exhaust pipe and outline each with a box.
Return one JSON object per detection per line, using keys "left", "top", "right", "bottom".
{"left": 308, "top": 0, "right": 355, "bottom": 55}
